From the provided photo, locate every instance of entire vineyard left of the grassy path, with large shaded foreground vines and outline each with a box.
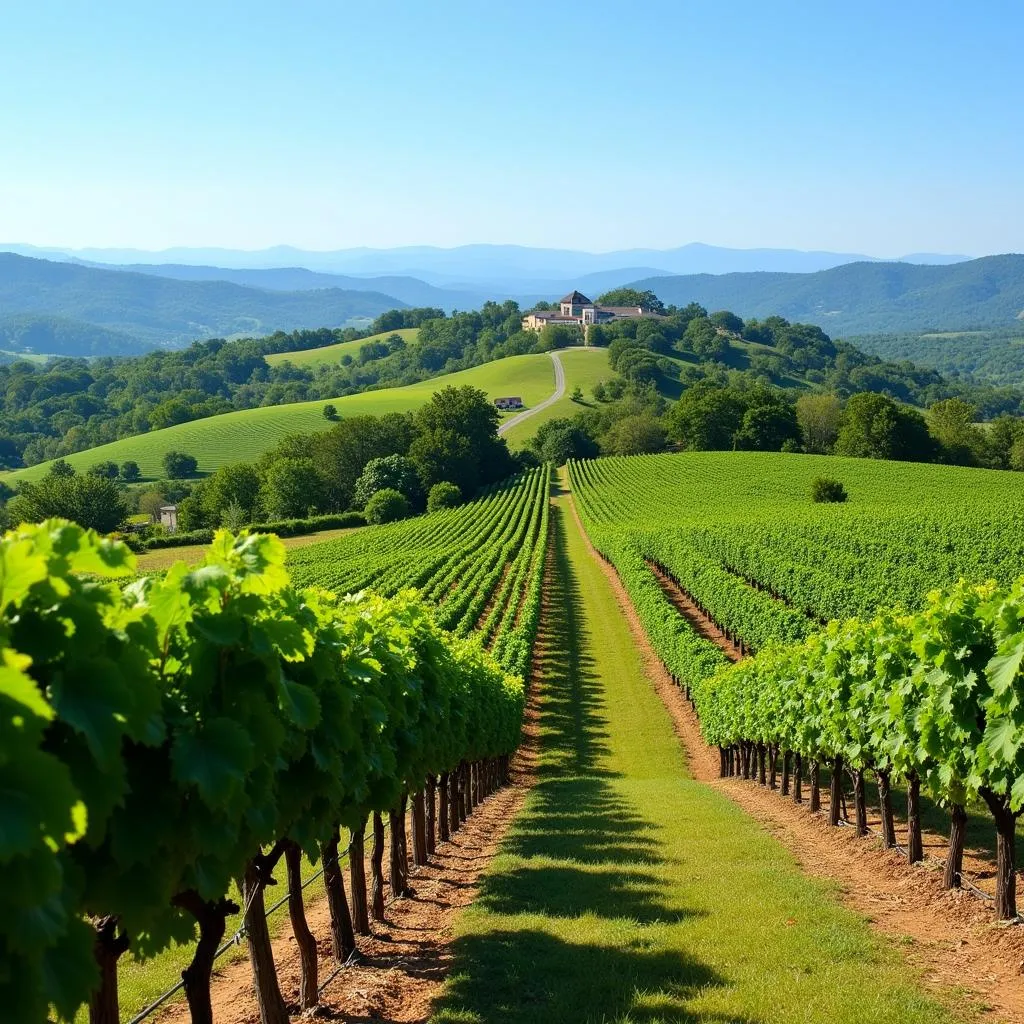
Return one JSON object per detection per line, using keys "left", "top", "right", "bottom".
{"left": 0, "top": 469, "right": 548, "bottom": 1024}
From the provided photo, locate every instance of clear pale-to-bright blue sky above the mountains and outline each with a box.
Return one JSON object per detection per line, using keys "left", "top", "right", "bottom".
{"left": 0, "top": 0, "right": 1024, "bottom": 256}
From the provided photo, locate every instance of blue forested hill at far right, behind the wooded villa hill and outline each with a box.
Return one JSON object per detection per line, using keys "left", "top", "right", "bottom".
{"left": 632, "top": 255, "right": 1024, "bottom": 336}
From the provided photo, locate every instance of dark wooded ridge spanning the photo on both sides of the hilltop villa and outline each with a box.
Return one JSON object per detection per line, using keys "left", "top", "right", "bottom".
{"left": 0, "top": 289, "right": 1022, "bottom": 469}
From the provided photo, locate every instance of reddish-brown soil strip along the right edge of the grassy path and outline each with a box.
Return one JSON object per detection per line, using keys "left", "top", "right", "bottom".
{"left": 570, "top": 487, "right": 1024, "bottom": 1024}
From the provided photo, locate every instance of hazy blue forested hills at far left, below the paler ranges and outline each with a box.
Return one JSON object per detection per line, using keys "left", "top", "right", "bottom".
{"left": 0, "top": 253, "right": 404, "bottom": 355}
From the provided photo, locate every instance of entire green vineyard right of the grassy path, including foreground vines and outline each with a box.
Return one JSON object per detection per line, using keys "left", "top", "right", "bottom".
{"left": 570, "top": 455, "right": 1024, "bottom": 919}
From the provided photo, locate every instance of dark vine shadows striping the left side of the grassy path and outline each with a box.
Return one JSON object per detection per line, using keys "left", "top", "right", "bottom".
{"left": 431, "top": 506, "right": 754, "bottom": 1024}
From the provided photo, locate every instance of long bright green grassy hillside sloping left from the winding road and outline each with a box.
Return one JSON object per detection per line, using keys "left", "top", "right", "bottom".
{"left": 3, "top": 352, "right": 569, "bottom": 483}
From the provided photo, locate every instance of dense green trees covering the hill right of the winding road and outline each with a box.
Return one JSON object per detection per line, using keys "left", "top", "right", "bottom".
{"left": 531, "top": 304, "right": 1024, "bottom": 470}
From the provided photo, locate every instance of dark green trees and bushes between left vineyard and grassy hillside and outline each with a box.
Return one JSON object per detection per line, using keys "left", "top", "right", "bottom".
{"left": 0, "top": 387, "right": 522, "bottom": 532}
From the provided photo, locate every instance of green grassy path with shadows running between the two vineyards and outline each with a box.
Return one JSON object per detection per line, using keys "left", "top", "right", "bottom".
{"left": 432, "top": 487, "right": 968, "bottom": 1024}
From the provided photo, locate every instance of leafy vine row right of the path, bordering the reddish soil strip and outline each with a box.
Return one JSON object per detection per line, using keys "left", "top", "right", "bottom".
{"left": 570, "top": 464, "right": 1024, "bottom": 919}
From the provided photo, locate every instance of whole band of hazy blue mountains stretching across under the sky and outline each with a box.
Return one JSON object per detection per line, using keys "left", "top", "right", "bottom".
{"left": 0, "top": 245, "right": 1024, "bottom": 355}
